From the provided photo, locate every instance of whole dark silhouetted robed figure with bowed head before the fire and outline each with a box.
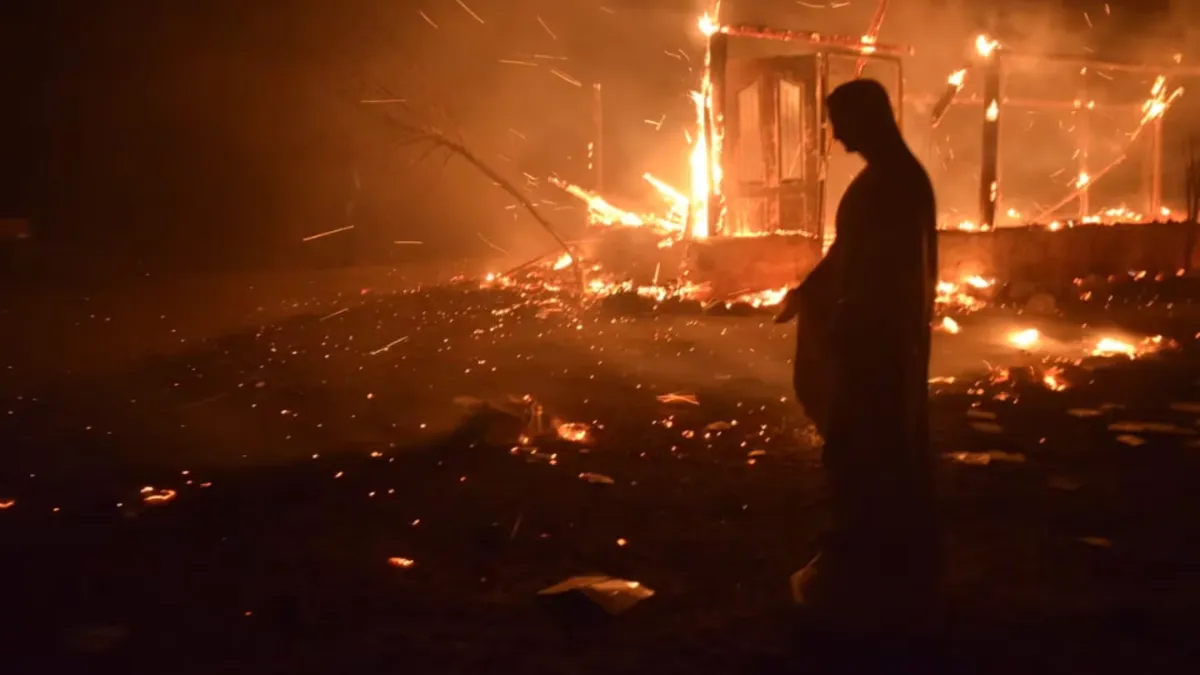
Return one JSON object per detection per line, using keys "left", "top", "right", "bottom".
{"left": 779, "top": 79, "right": 941, "bottom": 631}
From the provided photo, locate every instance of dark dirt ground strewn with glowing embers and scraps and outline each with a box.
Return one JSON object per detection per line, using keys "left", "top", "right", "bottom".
{"left": 0, "top": 265, "right": 1200, "bottom": 673}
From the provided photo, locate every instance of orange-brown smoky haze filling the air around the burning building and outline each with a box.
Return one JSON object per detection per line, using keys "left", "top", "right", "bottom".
{"left": 0, "top": 0, "right": 1200, "bottom": 277}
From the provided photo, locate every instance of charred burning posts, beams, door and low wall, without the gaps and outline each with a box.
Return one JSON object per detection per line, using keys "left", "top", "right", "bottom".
{"left": 558, "top": 9, "right": 1200, "bottom": 297}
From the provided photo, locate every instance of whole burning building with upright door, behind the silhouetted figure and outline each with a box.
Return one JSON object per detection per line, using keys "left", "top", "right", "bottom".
{"left": 559, "top": 1, "right": 1200, "bottom": 294}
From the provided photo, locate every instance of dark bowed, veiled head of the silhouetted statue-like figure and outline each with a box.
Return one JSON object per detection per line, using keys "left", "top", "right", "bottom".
{"left": 826, "top": 79, "right": 904, "bottom": 160}
